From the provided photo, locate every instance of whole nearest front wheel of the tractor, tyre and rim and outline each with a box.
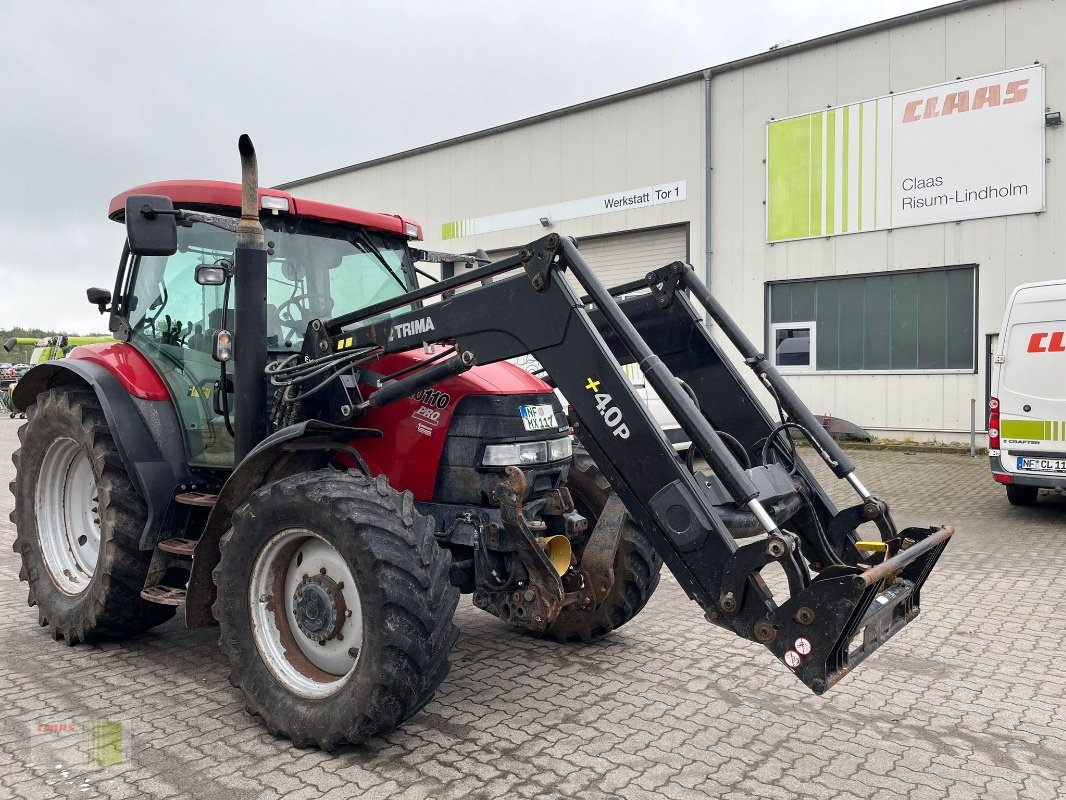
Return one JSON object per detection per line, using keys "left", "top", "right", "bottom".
{"left": 214, "top": 469, "right": 458, "bottom": 751}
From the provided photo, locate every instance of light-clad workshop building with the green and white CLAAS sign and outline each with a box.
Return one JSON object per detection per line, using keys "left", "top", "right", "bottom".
{"left": 282, "top": 0, "right": 1066, "bottom": 441}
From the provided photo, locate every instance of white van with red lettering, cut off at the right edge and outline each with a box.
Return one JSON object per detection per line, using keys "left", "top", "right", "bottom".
{"left": 988, "top": 279, "right": 1066, "bottom": 506}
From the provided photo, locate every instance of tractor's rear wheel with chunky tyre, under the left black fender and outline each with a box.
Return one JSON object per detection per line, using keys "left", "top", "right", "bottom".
{"left": 11, "top": 388, "right": 176, "bottom": 644}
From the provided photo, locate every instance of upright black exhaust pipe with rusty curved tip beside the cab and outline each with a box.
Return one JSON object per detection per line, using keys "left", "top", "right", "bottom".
{"left": 233, "top": 133, "right": 268, "bottom": 464}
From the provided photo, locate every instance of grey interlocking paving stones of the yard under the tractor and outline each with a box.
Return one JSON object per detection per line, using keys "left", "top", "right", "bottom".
{"left": 0, "top": 419, "right": 1066, "bottom": 800}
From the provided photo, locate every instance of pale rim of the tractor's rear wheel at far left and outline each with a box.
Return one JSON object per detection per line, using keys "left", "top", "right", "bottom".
{"left": 36, "top": 437, "right": 100, "bottom": 595}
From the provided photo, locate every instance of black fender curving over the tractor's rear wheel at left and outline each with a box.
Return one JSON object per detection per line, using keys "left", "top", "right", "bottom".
{"left": 12, "top": 358, "right": 192, "bottom": 549}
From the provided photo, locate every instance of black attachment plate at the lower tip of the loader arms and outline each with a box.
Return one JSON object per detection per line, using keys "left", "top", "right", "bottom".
{"left": 769, "top": 527, "right": 955, "bottom": 694}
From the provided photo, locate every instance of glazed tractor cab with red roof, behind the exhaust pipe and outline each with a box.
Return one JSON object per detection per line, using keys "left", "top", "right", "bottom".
{"left": 111, "top": 181, "right": 421, "bottom": 468}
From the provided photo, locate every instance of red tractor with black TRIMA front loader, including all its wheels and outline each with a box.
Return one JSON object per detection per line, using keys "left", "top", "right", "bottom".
{"left": 12, "top": 137, "right": 952, "bottom": 749}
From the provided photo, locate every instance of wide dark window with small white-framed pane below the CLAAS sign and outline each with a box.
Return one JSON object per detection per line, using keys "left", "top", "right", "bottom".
{"left": 766, "top": 265, "right": 976, "bottom": 372}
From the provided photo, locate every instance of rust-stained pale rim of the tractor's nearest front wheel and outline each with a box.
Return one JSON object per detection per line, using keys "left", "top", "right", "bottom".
{"left": 248, "top": 528, "right": 362, "bottom": 698}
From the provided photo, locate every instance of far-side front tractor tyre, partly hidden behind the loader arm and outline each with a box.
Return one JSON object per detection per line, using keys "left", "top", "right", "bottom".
{"left": 536, "top": 447, "right": 663, "bottom": 642}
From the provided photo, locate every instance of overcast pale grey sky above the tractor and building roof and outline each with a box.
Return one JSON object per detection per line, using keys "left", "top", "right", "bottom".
{"left": 6, "top": 0, "right": 936, "bottom": 332}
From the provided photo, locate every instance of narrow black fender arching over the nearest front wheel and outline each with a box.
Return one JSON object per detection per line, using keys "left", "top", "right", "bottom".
{"left": 185, "top": 419, "right": 382, "bottom": 628}
